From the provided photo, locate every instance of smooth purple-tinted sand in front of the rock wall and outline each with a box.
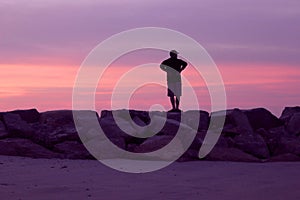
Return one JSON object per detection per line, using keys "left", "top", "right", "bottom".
{"left": 0, "top": 156, "right": 300, "bottom": 200}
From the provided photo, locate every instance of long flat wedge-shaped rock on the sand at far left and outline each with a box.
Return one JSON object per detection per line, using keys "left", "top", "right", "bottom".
{"left": 0, "top": 138, "right": 61, "bottom": 158}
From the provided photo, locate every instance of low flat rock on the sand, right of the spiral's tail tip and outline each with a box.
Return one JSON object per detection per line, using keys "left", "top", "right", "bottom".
{"left": 204, "top": 147, "right": 260, "bottom": 162}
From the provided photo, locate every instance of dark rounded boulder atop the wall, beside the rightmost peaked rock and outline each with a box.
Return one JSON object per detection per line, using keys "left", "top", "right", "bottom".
{"left": 244, "top": 108, "right": 283, "bottom": 130}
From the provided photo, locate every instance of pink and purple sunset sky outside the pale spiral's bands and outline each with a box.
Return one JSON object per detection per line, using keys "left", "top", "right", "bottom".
{"left": 0, "top": 0, "right": 300, "bottom": 116}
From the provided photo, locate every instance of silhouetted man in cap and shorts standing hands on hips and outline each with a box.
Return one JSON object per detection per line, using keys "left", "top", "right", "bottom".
{"left": 160, "top": 50, "right": 187, "bottom": 112}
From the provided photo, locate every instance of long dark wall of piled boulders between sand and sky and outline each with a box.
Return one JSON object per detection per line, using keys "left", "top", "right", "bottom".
{"left": 0, "top": 107, "right": 300, "bottom": 162}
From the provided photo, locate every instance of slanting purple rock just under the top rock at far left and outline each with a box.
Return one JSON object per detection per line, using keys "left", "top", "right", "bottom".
{"left": 3, "top": 113, "right": 34, "bottom": 138}
